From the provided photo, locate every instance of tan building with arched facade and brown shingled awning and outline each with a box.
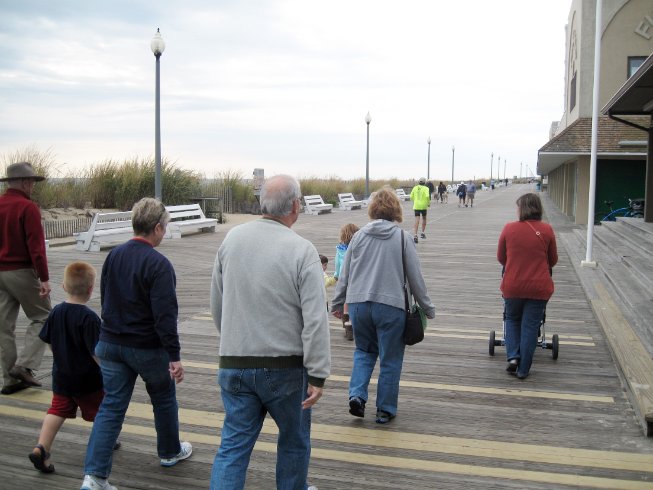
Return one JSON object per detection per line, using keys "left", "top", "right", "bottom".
{"left": 537, "top": 0, "right": 653, "bottom": 224}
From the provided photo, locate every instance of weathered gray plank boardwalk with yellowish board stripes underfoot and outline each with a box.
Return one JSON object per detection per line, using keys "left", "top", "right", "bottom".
{"left": 0, "top": 185, "right": 653, "bottom": 490}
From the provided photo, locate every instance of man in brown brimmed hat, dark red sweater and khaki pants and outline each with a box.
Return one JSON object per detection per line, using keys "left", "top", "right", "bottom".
{"left": 0, "top": 162, "right": 51, "bottom": 395}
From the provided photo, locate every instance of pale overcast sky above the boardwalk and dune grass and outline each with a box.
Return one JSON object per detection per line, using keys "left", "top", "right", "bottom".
{"left": 0, "top": 0, "right": 571, "bottom": 180}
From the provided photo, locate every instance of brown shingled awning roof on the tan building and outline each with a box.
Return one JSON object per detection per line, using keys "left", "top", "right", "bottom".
{"left": 537, "top": 116, "right": 650, "bottom": 175}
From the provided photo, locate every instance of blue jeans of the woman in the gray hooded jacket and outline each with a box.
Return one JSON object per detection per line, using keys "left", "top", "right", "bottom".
{"left": 349, "top": 301, "right": 406, "bottom": 415}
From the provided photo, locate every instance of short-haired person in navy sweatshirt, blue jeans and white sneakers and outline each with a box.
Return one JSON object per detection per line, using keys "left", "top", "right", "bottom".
{"left": 81, "top": 198, "right": 192, "bottom": 490}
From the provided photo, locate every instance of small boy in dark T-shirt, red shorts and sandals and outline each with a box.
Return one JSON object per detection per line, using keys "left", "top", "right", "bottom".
{"left": 29, "top": 262, "right": 119, "bottom": 473}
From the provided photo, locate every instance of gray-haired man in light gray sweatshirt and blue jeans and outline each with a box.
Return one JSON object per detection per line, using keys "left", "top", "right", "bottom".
{"left": 211, "top": 175, "right": 331, "bottom": 490}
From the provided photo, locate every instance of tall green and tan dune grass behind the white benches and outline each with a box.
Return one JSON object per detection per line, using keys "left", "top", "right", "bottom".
{"left": 0, "top": 146, "right": 415, "bottom": 210}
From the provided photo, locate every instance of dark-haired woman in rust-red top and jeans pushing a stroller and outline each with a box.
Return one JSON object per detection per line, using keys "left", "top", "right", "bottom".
{"left": 497, "top": 193, "right": 558, "bottom": 379}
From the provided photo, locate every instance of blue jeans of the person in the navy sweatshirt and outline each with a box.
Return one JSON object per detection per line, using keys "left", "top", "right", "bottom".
{"left": 84, "top": 341, "right": 181, "bottom": 478}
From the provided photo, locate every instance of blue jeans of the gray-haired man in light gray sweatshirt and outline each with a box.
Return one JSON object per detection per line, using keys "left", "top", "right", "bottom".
{"left": 211, "top": 367, "right": 311, "bottom": 490}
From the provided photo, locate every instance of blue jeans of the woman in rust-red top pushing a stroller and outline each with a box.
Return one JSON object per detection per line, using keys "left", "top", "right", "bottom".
{"left": 504, "top": 298, "right": 547, "bottom": 376}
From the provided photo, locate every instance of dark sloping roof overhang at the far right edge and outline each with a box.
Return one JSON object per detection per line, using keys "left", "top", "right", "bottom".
{"left": 601, "top": 54, "right": 653, "bottom": 116}
